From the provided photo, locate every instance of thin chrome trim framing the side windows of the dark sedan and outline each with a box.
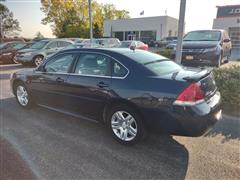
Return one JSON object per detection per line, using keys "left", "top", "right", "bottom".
{"left": 35, "top": 51, "right": 130, "bottom": 79}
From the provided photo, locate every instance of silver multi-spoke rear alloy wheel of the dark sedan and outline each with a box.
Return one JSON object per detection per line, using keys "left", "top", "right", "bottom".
{"left": 111, "top": 111, "right": 138, "bottom": 141}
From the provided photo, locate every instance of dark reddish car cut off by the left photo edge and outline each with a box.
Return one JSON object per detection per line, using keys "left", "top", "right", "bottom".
{"left": 0, "top": 41, "right": 28, "bottom": 64}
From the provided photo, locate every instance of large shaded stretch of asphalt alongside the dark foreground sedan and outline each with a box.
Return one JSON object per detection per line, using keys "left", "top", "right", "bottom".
{"left": 0, "top": 98, "right": 189, "bottom": 179}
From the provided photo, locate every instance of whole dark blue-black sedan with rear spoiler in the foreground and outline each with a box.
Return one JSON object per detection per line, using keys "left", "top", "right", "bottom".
{"left": 11, "top": 48, "right": 221, "bottom": 144}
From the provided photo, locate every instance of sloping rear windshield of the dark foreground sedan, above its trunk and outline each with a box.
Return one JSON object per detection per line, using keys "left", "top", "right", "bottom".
{"left": 144, "top": 60, "right": 181, "bottom": 76}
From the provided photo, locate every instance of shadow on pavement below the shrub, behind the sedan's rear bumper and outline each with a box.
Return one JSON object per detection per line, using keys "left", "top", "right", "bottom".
{"left": 205, "top": 116, "right": 240, "bottom": 142}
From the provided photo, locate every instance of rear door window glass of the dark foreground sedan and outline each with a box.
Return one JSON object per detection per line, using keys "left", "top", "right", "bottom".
{"left": 75, "top": 53, "right": 111, "bottom": 76}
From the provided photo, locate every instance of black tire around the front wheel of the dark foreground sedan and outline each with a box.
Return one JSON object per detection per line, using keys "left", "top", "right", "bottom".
{"left": 14, "top": 82, "right": 34, "bottom": 109}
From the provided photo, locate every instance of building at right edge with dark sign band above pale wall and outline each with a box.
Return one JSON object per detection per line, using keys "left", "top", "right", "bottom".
{"left": 213, "top": 5, "right": 240, "bottom": 48}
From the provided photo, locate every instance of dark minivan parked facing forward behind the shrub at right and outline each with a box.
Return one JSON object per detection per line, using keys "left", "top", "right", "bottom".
{"left": 172, "top": 30, "right": 232, "bottom": 67}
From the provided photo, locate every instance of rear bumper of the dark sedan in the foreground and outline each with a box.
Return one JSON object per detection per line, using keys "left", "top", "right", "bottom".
{"left": 144, "top": 92, "right": 222, "bottom": 137}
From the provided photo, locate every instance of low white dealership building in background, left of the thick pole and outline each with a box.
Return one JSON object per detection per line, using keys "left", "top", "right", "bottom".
{"left": 103, "top": 16, "right": 178, "bottom": 42}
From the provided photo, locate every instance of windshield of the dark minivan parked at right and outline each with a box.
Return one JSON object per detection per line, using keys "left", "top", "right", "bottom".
{"left": 183, "top": 31, "right": 221, "bottom": 41}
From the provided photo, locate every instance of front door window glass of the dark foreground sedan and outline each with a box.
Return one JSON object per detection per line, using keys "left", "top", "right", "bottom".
{"left": 45, "top": 54, "right": 75, "bottom": 73}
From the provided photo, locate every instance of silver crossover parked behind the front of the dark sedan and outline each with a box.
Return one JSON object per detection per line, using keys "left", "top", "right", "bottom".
{"left": 16, "top": 39, "right": 73, "bottom": 66}
